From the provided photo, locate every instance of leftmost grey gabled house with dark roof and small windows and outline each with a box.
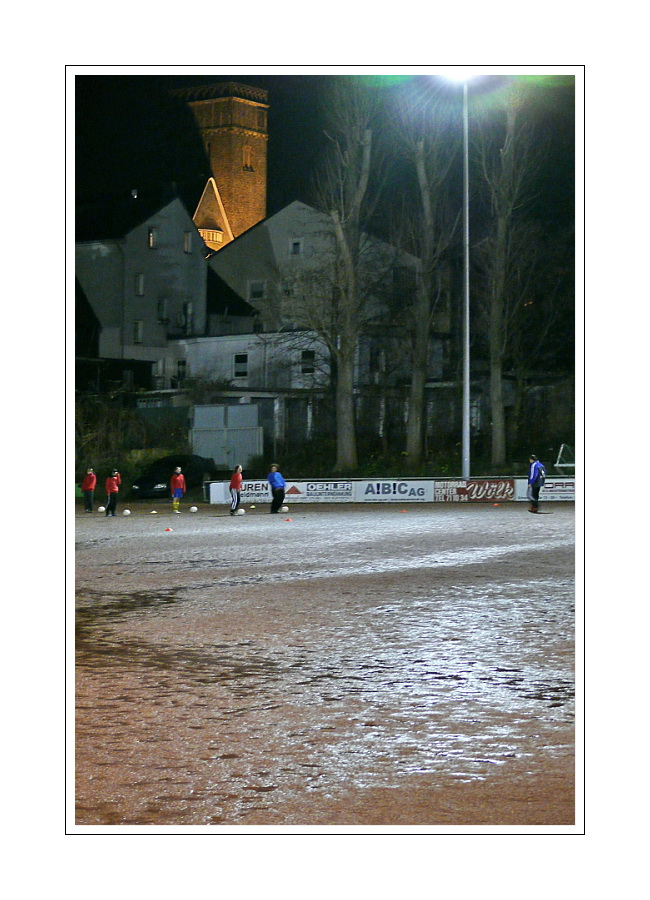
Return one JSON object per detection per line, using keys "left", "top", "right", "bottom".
{"left": 75, "top": 196, "right": 207, "bottom": 387}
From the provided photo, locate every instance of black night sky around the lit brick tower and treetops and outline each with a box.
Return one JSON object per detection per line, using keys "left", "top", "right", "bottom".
{"left": 75, "top": 74, "right": 574, "bottom": 230}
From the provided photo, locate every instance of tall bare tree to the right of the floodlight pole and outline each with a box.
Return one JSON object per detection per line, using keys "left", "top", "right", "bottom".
{"left": 478, "top": 85, "right": 543, "bottom": 466}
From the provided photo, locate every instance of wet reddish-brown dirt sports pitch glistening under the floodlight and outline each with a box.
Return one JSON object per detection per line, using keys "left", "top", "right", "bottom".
{"left": 75, "top": 501, "right": 575, "bottom": 833}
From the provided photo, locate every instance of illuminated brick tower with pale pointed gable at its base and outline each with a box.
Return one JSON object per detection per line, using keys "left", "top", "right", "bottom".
{"left": 173, "top": 82, "right": 268, "bottom": 250}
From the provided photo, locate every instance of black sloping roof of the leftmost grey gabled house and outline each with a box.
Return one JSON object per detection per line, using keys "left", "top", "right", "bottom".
{"left": 75, "top": 188, "right": 191, "bottom": 243}
